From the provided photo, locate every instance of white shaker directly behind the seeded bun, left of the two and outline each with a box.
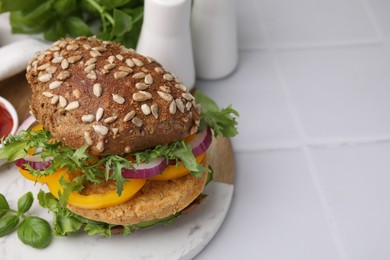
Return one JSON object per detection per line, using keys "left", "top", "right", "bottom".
{"left": 136, "top": 0, "right": 195, "bottom": 89}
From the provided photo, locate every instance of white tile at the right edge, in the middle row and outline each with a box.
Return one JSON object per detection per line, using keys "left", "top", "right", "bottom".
{"left": 278, "top": 45, "right": 390, "bottom": 141}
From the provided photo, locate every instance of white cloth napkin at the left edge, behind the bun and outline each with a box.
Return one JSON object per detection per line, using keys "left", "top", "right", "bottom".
{"left": 0, "top": 39, "right": 49, "bottom": 80}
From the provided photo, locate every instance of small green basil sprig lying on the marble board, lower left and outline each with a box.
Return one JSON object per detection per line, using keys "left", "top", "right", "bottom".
{"left": 0, "top": 192, "right": 52, "bottom": 248}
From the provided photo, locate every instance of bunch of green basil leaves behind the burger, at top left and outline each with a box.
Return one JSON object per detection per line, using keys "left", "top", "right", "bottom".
{"left": 0, "top": 0, "right": 144, "bottom": 48}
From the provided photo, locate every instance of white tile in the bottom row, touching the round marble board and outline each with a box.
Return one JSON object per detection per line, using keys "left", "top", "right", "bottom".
{"left": 199, "top": 150, "right": 339, "bottom": 260}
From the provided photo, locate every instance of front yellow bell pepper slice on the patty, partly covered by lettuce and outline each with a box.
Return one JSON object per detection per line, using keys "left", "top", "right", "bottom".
{"left": 46, "top": 169, "right": 146, "bottom": 209}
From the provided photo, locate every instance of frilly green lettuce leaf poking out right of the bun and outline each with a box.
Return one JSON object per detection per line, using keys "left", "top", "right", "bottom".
{"left": 195, "top": 91, "right": 239, "bottom": 137}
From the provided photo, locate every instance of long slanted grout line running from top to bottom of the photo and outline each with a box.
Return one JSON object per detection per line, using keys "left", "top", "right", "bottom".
{"left": 252, "top": 0, "right": 348, "bottom": 260}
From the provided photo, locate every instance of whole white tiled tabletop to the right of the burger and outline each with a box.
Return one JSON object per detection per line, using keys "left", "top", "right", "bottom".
{"left": 197, "top": 0, "right": 390, "bottom": 260}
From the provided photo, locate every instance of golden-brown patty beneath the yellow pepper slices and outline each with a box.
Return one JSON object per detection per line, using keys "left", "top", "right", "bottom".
{"left": 68, "top": 156, "right": 208, "bottom": 225}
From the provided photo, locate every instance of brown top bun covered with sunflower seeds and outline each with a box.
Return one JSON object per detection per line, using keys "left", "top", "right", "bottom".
{"left": 26, "top": 37, "right": 200, "bottom": 155}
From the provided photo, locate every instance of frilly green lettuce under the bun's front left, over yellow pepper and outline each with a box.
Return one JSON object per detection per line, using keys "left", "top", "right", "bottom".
{"left": 0, "top": 130, "right": 132, "bottom": 199}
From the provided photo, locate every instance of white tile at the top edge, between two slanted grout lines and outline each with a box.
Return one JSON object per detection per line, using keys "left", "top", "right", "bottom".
{"left": 257, "top": 0, "right": 377, "bottom": 46}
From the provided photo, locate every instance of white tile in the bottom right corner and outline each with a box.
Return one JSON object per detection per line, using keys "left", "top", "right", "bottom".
{"left": 313, "top": 142, "right": 390, "bottom": 260}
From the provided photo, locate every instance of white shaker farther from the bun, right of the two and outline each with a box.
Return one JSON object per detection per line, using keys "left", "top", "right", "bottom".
{"left": 191, "top": 0, "right": 238, "bottom": 79}
